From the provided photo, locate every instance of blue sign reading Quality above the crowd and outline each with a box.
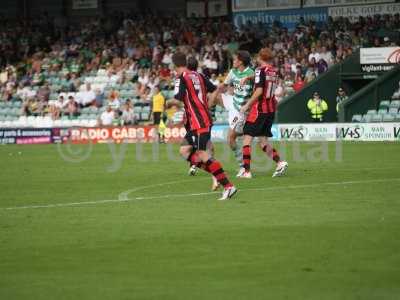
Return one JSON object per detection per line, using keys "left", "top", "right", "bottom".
{"left": 233, "top": 7, "right": 328, "bottom": 29}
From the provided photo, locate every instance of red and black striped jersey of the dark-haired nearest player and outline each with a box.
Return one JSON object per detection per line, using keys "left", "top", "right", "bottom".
{"left": 174, "top": 71, "right": 216, "bottom": 133}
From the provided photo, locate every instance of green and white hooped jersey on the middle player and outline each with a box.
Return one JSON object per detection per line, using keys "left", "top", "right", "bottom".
{"left": 224, "top": 67, "right": 254, "bottom": 111}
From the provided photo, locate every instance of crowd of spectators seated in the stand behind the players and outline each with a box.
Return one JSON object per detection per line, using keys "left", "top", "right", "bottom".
{"left": 0, "top": 13, "right": 400, "bottom": 124}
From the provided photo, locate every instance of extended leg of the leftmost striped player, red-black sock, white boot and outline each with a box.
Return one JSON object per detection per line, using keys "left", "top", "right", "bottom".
{"left": 194, "top": 132, "right": 237, "bottom": 200}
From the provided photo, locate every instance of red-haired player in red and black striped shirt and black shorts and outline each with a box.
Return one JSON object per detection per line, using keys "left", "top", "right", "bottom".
{"left": 237, "top": 48, "right": 288, "bottom": 178}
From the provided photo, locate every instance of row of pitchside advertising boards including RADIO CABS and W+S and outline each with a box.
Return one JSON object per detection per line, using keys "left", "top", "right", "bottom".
{"left": 0, "top": 123, "right": 400, "bottom": 144}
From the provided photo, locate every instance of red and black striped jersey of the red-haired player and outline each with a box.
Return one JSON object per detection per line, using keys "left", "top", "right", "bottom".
{"left": 247, "top": 65, "right": 278, "bottom": 122}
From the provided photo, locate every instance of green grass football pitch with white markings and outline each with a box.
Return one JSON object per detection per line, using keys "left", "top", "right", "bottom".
{"left": 0, "top": 143, "right": 400, "bottom": 300}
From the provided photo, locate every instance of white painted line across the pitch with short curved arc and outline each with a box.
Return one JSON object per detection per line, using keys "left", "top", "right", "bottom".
{"left": 0, "top": 178, "right": 400, "bottom": 210}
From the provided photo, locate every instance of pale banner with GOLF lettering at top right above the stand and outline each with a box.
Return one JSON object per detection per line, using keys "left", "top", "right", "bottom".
{"left": 328, "top": 3, "right": 400, "bottom": 22}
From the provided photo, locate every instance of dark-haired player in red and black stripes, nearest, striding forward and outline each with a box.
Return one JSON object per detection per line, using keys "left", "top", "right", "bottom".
{"left": 172, "top": 52, "right": 237, "bottom": 200}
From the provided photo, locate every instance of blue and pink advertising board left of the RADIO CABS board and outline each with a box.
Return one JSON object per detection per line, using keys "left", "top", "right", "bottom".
{"left": 0, "top": 128, "right": 53, "bottom": 144}
